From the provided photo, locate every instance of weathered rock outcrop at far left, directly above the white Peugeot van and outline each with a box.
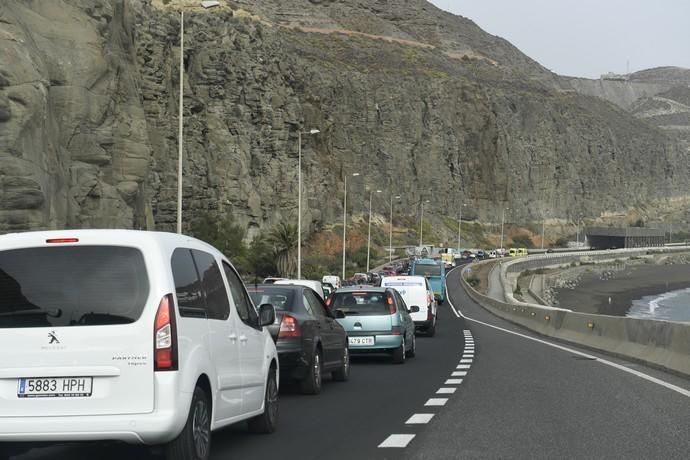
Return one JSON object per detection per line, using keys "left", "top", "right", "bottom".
{"left": 0, "top": 0, "right": 151, "bottom": 231}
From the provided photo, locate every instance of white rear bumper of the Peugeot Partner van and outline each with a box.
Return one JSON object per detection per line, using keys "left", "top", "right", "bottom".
{"left": 0, "top": 373, "right": 192, "bottom": 445}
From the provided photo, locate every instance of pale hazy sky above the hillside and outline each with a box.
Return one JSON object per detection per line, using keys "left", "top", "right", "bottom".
{"left": 430, "top": 0, "right": 690, "bottom": 78}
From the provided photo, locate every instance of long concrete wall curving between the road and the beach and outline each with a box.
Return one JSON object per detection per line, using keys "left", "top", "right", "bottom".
{"left": 460, "top": 248, "right": 690, "bottom": 376}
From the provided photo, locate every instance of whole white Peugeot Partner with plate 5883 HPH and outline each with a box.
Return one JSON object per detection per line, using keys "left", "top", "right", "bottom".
{"left": 0, "top": 230, "right": 279, "bottom": 460}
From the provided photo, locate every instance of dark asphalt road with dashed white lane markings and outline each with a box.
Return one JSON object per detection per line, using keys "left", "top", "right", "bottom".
{"left": 10, "top": 264, "right": 690, "bottom": 460}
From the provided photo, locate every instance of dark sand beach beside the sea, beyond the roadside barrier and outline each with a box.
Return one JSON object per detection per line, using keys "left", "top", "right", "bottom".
{"left": 554, "top": 264, "right": 690, "bottom": 316}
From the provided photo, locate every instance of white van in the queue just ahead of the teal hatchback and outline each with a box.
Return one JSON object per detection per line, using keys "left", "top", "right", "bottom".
{"left": 381, "top": 276, "right": 437, "bottom": 337}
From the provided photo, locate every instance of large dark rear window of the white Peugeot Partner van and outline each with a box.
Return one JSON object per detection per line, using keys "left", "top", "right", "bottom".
{"left": 0, "top": 246, "right": 149, "bottom": 328}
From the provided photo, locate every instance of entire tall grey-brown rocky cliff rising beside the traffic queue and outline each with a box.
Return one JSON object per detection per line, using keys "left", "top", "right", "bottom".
{"left": 0, "top": 0, "right": 689, "bottom": 237}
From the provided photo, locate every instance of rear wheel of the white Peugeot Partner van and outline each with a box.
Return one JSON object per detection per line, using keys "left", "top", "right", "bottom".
{"left": 165, "top": 387, "right": 211, "bottom": 460}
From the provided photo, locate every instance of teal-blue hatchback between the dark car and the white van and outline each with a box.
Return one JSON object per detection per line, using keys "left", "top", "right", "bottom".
{"left": 328, "top": 286, "right": 419, "bottom": 363}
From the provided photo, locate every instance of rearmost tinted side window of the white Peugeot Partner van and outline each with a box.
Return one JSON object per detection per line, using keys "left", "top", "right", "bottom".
{"left": 170, "top": 248, "right": 206, "bottom": 318}
